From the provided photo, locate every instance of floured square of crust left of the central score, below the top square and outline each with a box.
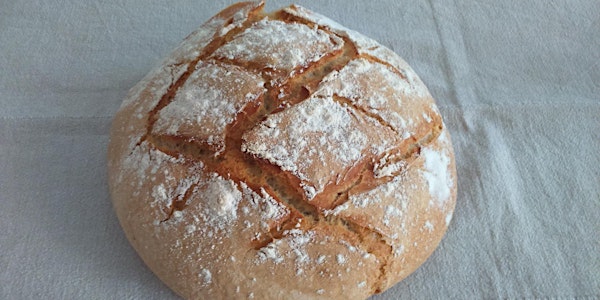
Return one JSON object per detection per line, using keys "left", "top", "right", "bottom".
{"left": 153, "top": 62, "right": 265, "bottom": 150}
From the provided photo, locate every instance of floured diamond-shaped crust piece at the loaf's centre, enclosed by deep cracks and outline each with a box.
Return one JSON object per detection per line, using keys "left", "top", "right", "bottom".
{"left": 242, "top": 97, "right": 369, "bottom": 199}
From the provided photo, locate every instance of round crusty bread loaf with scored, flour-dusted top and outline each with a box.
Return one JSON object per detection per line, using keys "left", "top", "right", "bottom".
{"left": 108, "top": 2, "right": 456, "bottom": 299}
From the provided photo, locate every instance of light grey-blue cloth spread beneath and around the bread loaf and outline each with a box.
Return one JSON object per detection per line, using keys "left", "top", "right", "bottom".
{"left": 0, "top": 0, "right": 600, "bottom": 299}
